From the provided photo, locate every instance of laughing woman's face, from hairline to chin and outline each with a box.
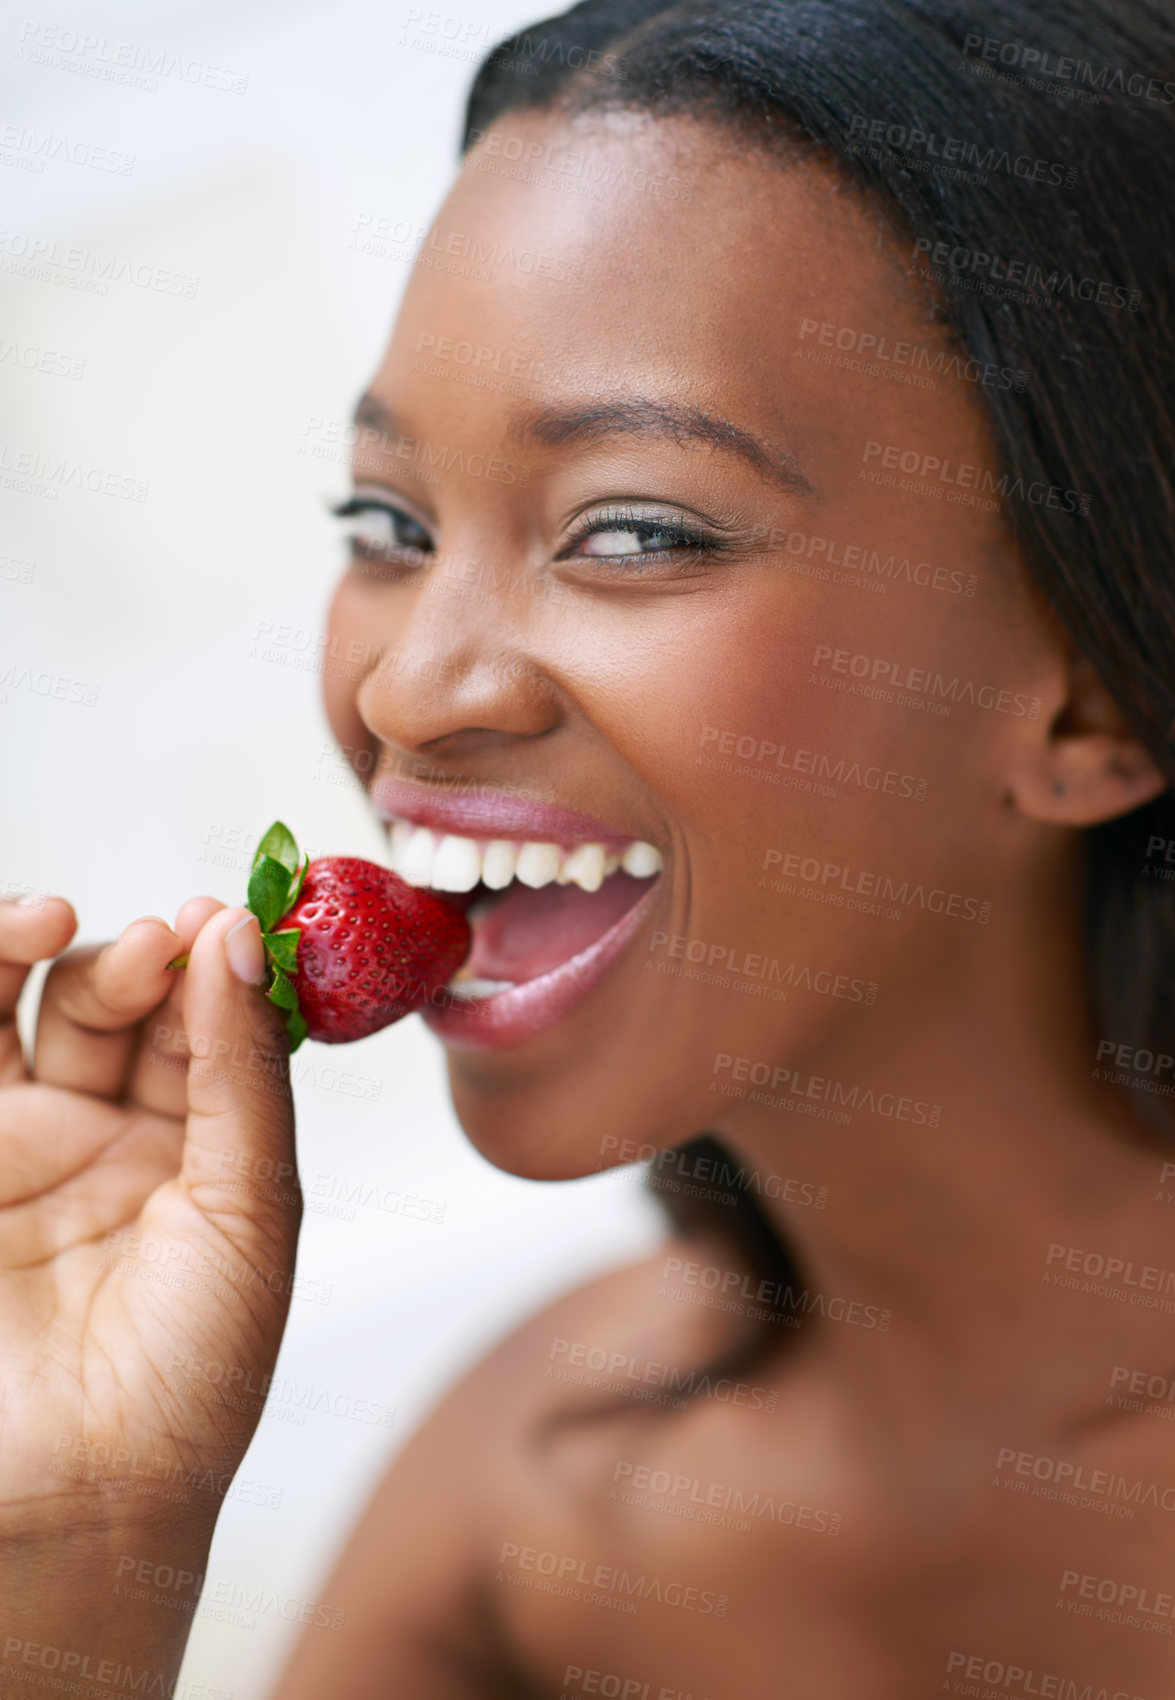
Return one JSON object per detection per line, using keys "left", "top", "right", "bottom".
{"left": 326, "top": 102, "right": 1059, "bottom": 1176}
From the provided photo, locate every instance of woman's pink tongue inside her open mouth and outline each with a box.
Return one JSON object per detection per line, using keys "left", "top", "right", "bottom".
{"left": 469, "top": 870, "right": 648, "bottom": 983}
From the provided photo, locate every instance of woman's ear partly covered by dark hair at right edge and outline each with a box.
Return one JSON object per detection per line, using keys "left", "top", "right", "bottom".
{"left": 1008, "top": 655, "right": 1168, "bottom": 826}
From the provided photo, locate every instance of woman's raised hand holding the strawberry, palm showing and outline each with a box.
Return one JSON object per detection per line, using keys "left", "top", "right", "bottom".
{"left": 0, "top": 898, "right": 301, "bottom": 1540}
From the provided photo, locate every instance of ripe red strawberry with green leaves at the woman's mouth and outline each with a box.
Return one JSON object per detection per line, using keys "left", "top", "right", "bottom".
{"left": 222, "top": 821, "right": 471, "bottom": 1051}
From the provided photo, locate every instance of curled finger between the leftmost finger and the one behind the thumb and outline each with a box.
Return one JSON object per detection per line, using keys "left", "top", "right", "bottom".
{"left": 32, "top": 916, "right": 184, "bottom": 1098}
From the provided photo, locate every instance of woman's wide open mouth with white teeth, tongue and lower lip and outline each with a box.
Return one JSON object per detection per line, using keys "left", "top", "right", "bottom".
{"left": 380, "top": 818, "right": 661, "bottom": 1046}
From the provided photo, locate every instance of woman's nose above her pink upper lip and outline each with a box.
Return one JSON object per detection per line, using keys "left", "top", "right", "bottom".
{"left": 355, "top": 563, "right": 563, "bottom": 762}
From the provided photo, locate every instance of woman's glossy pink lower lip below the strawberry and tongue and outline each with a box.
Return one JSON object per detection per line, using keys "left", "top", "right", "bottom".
{"left": 422, "top": 874, "right": 661, "bottom": 1051}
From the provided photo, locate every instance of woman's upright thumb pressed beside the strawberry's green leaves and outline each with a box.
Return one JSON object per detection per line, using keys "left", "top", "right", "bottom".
{"left": 180, "top": 910, "right": 301, "bottom": 1256}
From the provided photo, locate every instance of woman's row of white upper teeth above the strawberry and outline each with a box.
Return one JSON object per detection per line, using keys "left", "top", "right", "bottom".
{"left": 388, "top": 821, "right": 661, "bottom": 891}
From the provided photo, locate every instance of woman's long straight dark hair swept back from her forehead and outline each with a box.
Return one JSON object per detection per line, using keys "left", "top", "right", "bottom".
{"left": 463, "top": 0, "right": 1175, "bottom": 1125}
